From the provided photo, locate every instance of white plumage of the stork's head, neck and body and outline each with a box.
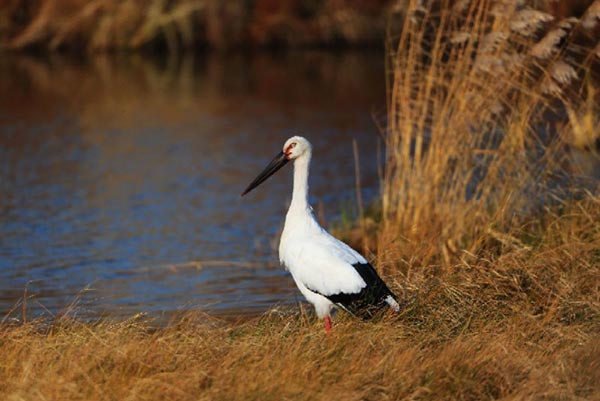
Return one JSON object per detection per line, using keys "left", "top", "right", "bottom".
{"left": 279, "top": 137, "right": 399, "bottom": 318}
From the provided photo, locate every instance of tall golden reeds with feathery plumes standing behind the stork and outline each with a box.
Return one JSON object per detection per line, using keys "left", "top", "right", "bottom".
{"left": 379, "top": 0, "right": 599, "bottom": 264}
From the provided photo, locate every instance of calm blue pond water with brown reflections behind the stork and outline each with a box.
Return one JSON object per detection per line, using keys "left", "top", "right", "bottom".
{"left": 0, "top": 52, "right": 385, "bottom": 318}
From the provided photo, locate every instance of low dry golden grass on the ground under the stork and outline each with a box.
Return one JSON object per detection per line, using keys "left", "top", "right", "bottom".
{"left": 0, "top": 195, "right": 600, "bottom": 400}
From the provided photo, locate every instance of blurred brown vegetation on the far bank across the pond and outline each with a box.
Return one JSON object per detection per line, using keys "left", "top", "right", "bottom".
{"left": 0, "top": 0, "right": 391, "bottom": 51}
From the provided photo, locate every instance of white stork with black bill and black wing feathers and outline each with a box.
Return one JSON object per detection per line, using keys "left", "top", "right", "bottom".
{"left": 242, "top": 136, "right": 400, "bottom": 333}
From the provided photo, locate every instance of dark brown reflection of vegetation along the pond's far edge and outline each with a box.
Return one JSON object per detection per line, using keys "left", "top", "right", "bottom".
{"left": 0, "top": 51, "right": 384, "bottom": 124}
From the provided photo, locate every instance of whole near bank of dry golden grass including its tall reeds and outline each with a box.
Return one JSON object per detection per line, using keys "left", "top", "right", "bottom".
{"left": 0, "top": 2, "right": 600, "bottom": 400}
